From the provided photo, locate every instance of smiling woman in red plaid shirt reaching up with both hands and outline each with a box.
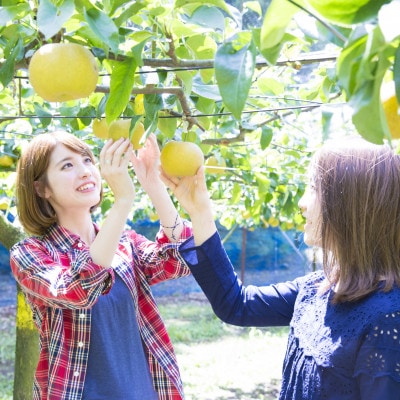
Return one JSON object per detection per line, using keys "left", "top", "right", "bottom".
{"left": 11, "top": 132, "right": 191, "bottom": 400}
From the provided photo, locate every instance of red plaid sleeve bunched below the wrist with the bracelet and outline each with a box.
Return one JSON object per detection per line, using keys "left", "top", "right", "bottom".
{"left": 129, "top": 221, "right": 192, "bottom": 285}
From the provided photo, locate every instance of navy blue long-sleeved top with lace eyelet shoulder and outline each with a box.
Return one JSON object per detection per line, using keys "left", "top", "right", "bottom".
{"left": 180, "top": 233, "right": 400, "bottom": 400}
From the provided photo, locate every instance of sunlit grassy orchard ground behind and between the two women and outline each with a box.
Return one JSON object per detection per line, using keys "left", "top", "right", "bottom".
{"left": 0, "top": 275, "right": 287, "bottom": 400}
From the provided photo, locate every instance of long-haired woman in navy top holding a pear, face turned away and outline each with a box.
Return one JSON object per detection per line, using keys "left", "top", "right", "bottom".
{"left": 163, "top": 140, "right": 400, "bottom": 400}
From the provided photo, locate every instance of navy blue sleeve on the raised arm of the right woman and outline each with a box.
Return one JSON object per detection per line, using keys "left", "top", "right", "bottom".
{"left": 180, "top": 232, "right": 298, "bottom": 326}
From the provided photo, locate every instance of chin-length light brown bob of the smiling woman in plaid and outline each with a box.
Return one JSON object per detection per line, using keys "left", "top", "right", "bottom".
{"left": 16, "top": 131, "right": 102, "bottom": 236}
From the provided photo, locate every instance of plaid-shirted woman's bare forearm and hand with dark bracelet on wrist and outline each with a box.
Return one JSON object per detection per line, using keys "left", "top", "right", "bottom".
{"left": 131, "top": 134, "right": 183, "bottom": 242}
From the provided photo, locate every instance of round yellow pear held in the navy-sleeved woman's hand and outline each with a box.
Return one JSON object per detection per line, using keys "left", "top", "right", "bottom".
{"left": 160, "top": 140, "right": 204, "bottom": 176}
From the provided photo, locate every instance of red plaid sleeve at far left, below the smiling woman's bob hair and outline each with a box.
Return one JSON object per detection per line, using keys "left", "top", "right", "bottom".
{"left": 10, "top": 238, "right": 114, "bottom": 309}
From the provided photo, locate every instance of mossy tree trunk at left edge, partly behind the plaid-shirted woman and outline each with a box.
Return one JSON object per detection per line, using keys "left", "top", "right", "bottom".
{"left": 0, "top": 213, "right": 39, "bottom": 400}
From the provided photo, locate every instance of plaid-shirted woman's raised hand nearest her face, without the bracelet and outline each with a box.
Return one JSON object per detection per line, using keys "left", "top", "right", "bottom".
{"left": 100, "top": 138, "right": 135, "bottom": 203}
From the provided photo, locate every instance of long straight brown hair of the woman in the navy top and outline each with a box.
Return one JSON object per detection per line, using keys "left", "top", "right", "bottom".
{"left": 313, "top": 139, "right": 400, "bottom": 303}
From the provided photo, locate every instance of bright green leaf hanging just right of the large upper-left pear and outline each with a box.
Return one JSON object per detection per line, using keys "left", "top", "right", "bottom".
{"left": 106, "top": 57, "right": 137, "bottom": 124}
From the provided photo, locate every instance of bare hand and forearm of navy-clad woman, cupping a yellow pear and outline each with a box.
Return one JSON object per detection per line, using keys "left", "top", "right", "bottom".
{"left": 161, "top": 167, "right": 217, "bottom": 246}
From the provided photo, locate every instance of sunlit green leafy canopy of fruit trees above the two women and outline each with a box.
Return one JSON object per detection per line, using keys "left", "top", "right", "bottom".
{"left": 0, "top": 0, "right": 400, "bottom": 234}
